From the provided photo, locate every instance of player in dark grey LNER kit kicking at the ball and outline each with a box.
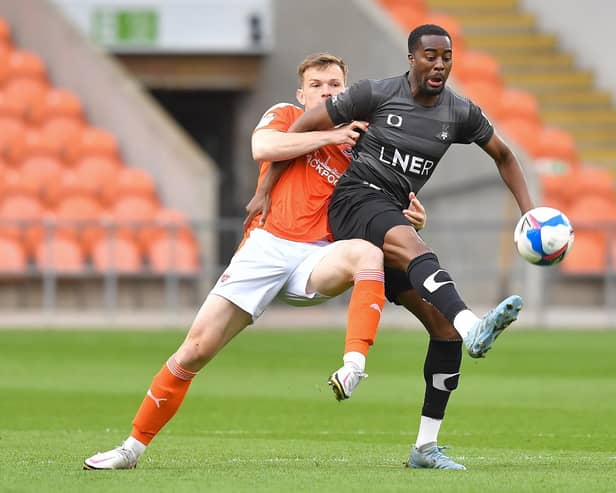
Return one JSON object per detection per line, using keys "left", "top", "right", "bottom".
{"left": 290, "top": 24, "right": 533, "bottom": 469}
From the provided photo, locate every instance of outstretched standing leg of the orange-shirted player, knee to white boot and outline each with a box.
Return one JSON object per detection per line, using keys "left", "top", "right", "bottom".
{"left": 83, "top": 294, "right": 252, "bottom": 469}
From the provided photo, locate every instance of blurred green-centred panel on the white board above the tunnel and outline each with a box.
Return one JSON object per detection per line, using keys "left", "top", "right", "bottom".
{"left": 92, "top": 8, "right": 159, "bottom": 46}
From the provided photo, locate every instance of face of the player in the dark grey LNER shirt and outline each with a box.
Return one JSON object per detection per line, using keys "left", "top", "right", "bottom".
{"left": 409, "top": 35, "right": 452, "bottom": 98}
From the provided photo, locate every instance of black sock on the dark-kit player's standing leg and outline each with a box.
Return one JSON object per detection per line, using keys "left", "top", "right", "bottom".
{"left": 421, "top": 339, "right": 462, "bottom": 419}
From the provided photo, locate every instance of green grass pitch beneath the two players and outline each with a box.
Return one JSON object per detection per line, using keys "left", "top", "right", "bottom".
{"left": 0, "top": 328, "right": 616, "bottom": 493}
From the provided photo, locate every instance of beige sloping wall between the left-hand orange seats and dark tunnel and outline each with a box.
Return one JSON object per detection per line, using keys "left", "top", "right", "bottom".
{"left": 0, "top": 0, "right": 219, "bottom": 270}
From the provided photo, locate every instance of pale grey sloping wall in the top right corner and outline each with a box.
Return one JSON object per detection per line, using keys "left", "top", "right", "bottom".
{"left": 522, "top": 0, "right": 616, "bottom": 102}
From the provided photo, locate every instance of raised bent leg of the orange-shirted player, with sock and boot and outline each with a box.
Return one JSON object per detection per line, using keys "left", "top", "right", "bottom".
{"left": 308, "top": 240, "right": 385, "bottom": 400}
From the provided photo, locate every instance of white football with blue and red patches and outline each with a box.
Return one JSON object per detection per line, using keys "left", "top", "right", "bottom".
{"left": 513, "top": 207, "right": 573, "bottom": 265}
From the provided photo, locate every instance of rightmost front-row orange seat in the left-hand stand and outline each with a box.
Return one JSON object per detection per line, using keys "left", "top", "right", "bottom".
{"left": 147, "top": 238, "right": 199, "bottom": 274}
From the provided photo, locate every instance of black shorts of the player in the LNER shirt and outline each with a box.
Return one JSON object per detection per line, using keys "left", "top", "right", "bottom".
{"left": 329, "top": 185, "right": 413, "bottom": 303}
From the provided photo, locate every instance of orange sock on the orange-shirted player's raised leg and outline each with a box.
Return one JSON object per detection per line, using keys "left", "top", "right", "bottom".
{"left": 344, "top": 269, "right": 385, "bottom": 356}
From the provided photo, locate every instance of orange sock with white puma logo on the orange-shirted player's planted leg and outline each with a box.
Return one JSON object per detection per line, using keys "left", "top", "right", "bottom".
{"left": 131, "top": 355, "right": 196, "bottom": 445}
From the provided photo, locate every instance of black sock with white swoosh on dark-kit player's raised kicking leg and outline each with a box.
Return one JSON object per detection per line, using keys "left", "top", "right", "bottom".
{"left": 406, "top": 252, "right": 467, "bottom": 325}
